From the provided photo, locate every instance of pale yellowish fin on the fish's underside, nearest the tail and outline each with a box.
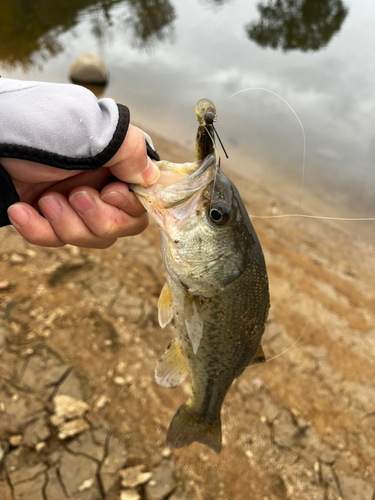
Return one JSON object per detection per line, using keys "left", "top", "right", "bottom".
{"left": 155, "top": 339, "right": 189, "bottom": 389}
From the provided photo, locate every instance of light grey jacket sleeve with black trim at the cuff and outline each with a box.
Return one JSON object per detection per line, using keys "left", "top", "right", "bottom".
{"left": 0, "top": 78, "right": 159, "bottom": 226}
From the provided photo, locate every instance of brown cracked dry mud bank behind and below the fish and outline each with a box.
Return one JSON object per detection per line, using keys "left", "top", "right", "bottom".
{"left": 0, "top": 137, "right": 375, "bottom": 500}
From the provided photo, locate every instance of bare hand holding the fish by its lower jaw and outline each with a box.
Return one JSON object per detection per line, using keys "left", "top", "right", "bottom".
{"left": 1, "top": 125, "right": 160, "bottom": 248}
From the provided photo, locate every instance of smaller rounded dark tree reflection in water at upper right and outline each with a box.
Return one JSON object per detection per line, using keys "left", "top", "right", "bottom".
{"left": 246, "top": 0, "right": 348, "bottom": 52}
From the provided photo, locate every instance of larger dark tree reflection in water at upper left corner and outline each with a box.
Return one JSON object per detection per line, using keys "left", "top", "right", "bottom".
{"left": 0, "top": 0, "right": 176, "bottom": 68}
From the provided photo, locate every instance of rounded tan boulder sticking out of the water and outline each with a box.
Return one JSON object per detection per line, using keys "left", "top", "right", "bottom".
{"left": 70, "top": 52, "right": 108, "bottom": 85}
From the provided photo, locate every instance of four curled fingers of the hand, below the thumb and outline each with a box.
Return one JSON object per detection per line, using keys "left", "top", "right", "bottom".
{"left": 8, "top": 182, "right": 148, "bottom": 248}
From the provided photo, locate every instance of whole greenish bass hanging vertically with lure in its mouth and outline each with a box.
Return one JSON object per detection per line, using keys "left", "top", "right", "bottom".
{"left": 131, "top": 99, "right": 270, "bottom": 453}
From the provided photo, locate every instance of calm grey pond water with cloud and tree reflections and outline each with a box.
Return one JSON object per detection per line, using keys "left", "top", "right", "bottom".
{"left": 0, "top": 0, "right": 375, "bottom": 240}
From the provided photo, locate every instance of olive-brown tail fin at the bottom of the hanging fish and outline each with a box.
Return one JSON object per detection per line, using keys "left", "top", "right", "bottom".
{"left": 167, "top": 404, "right": 221, "bottom": 453}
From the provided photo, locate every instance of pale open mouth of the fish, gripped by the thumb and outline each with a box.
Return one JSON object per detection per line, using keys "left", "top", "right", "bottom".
{"left": 130, "top": 154, "right": 216, "bottom": 207}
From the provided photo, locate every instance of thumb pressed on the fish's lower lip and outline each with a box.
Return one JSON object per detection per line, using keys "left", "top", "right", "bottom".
{"left": 105, "top": 125, "right": 160, "bottom": 186}
